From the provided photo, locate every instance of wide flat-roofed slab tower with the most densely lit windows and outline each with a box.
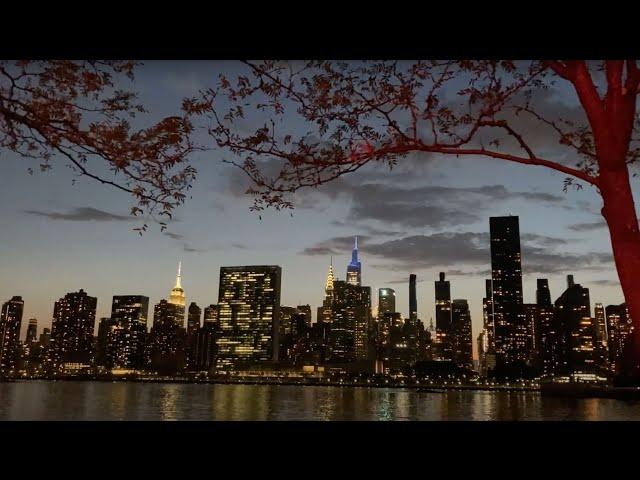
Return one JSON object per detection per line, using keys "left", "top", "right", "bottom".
{"left": 216, "top": 265, "right": 282, "bottom": 370}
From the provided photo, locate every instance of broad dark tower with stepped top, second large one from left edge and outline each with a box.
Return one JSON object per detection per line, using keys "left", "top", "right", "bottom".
{"left": 51, "top": 289, "right": 98, "bottom": 373}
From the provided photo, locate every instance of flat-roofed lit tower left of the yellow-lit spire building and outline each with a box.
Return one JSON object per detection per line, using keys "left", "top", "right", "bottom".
{"left": 110, "top": 295, "right": 149, "bottom": 370}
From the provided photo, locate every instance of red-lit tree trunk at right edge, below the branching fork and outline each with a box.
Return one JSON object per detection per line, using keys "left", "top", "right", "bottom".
{"left": 599, "top": 162, "right": 640, "bottom": 379}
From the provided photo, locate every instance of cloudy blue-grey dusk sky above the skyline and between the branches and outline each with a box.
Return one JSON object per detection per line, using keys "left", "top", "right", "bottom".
{"left": 0, "top": 61, "right": 638, "bottom": 356}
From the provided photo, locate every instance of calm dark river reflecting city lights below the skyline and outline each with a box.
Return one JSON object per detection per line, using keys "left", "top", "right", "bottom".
{"left": 0, "top": 381, "right": 640, "bottom": 420}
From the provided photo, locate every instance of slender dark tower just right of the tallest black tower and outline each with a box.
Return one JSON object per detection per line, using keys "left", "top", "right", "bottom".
{"left": 536, "top": 278, "right": 563, "bottom": 377}
